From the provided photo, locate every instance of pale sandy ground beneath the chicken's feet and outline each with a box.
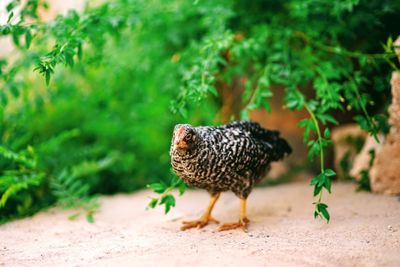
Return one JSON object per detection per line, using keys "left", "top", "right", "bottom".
{"left": 0, "top": 182, "right": 400, "bottom": 266}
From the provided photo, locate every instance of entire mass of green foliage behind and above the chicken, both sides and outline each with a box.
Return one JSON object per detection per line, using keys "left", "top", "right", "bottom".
{"left": 0, "top": 0, "right": 400, "bottom": 224}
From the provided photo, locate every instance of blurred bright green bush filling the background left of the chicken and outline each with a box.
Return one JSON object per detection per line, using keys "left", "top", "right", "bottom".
{"left": 0, "top": 1, "right": 219, "bottom": 221}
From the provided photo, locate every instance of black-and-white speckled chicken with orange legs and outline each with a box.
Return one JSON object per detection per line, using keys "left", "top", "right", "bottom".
{"left": 170, "top": 120, "right": 292, "bottom": 232}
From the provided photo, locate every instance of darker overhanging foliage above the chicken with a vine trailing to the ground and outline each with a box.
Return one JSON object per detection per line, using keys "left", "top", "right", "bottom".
{"left": 148, "top": 0, "right": 400, "bottom": 221}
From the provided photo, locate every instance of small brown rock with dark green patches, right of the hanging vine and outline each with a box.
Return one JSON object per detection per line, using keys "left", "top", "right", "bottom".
{"left": 332, "top": 124, "right": 368, "bottom": 178}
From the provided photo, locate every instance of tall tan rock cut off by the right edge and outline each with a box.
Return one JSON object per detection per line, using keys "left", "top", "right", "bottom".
{"left": 370, "top": 64, "right": 400, "bottom": 194}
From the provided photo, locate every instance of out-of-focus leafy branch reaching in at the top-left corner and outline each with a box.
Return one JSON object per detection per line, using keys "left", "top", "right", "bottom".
{"left": 0, "top": 0, "right": 129, "bottom": 85}
